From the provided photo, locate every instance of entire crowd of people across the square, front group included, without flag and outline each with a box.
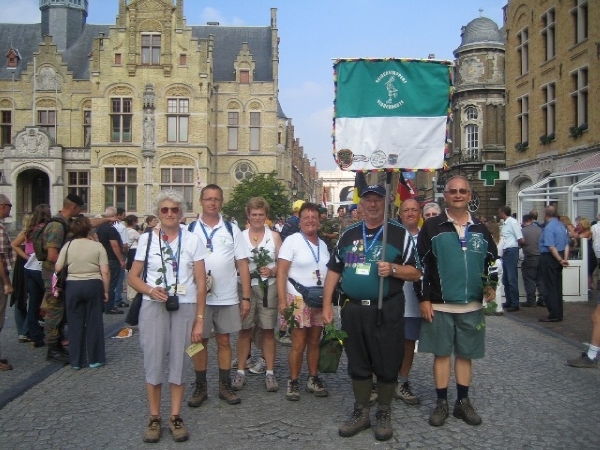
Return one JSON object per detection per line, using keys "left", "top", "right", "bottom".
{"left": 0, "top": 185, "right": 600, "bottom": 442}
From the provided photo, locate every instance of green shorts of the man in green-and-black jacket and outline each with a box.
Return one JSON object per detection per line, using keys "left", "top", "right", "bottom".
{"left": 419, "top": 309, "right": 485, "bottom": 359}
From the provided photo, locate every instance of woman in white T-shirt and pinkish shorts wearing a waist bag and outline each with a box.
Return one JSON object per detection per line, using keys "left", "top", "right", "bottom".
{"left": 277, "top": 203, "right": 329, "bottom": 401}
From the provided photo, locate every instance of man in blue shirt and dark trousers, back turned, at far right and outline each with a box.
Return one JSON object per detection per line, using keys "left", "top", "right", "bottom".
{"left": 539, "top": 206, "right": 569, "bottom": 322}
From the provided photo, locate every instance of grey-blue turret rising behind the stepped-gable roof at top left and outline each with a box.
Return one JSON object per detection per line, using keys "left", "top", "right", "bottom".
{"left": 40, "top": 0, "right": 88, "bottom": 52}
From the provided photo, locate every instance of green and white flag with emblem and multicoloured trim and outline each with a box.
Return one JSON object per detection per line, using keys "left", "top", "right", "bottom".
{"left": 334, "top": 59, "right": 452, "bottom": 170}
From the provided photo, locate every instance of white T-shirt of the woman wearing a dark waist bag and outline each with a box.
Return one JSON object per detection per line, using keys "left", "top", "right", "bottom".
{"left": 279, "top": 233, "right": 329, "bottom": 295}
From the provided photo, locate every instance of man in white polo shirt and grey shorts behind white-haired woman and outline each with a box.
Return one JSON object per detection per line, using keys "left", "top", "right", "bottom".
{"left": 188, "top": 184, "right": 252, "bottom": 407}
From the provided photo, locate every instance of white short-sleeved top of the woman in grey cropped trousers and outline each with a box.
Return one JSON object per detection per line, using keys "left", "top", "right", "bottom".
{"left": 135, "top": 229, "right": 208, "bottom": 303}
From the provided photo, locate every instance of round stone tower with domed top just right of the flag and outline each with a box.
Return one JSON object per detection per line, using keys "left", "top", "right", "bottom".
{"left": 445, "top": 17, "right": 506, "bottom": 221}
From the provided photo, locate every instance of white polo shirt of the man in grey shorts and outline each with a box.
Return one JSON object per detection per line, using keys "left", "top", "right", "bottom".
{"left": 193, "top": 215, "right": 251, "bottom": 306}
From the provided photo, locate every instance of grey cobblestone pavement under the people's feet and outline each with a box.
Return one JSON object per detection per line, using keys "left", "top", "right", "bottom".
{"left": 0, "top": 308, "right": 600, "bottom": 450}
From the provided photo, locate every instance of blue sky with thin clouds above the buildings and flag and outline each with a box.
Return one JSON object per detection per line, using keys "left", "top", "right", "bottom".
{"left": 0, "top": 0, "right": 507, "bottom": 170}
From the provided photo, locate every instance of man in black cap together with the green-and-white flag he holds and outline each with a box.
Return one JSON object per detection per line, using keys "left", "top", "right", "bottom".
{"left": 323, "top": 58, "right": 452, "bottom": 441}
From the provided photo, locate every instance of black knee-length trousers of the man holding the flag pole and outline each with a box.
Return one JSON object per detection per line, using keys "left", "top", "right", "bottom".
{"left": 341, "top": 291, "right": 404, "bottom": 383}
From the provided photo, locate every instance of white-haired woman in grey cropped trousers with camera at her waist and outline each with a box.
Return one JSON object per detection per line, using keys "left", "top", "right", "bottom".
{"left": 129, "top": 191, "right": 207, "bottom": 442}
